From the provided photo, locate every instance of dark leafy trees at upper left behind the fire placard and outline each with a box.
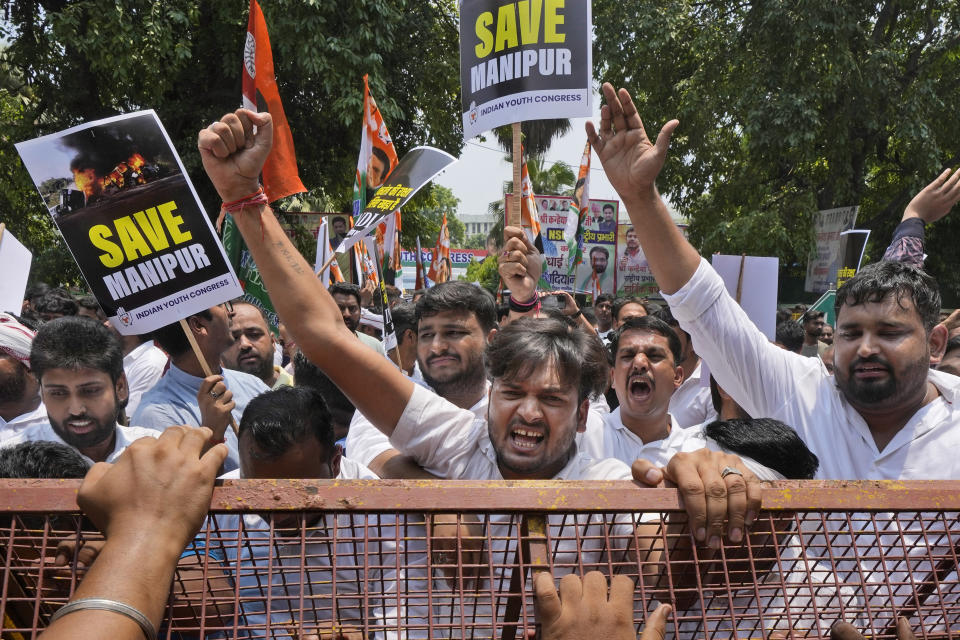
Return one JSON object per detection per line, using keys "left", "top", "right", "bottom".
{"left": 0, "top": 0, "right": 463, "bottom": 282}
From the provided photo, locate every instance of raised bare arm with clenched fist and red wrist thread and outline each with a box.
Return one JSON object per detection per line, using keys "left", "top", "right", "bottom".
{"left": 197, "top": 109, "right": 413, "bottom": 435}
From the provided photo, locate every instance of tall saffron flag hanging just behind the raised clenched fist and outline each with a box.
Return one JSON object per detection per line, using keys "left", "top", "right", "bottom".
{"left": 242, "top": 0, "right": 306, "bottom": 202}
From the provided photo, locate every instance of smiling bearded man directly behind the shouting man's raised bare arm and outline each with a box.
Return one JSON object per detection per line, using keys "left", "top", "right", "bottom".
{"left": 347, "top": 281, "right": 497, "bottom": 477}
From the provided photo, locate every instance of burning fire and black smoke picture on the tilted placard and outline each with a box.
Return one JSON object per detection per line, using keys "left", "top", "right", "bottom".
{"left": 55, "top": 119, "right": 176, "bottom": 215}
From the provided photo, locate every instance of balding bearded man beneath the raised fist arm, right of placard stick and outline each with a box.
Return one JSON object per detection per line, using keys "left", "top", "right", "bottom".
{"left": 220, "top": 300, "right": 293, "bottom": 389}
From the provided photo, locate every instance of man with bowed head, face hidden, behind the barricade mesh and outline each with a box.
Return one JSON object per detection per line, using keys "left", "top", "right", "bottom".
{"left": 205, "top": 387, "right": 406, "bottom": 637}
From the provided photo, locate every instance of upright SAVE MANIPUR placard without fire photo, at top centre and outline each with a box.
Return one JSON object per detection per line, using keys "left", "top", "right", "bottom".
{"left": 460, "top": 0, "right": 593, "bottom": 140}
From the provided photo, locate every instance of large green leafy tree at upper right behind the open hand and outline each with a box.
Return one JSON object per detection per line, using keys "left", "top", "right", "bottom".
{"left": 593, "top": 0, "right": 960, "bottom": 290}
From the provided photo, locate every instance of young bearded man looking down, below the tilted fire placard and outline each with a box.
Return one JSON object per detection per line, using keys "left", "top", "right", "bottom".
{"left": 3, "top": 316, "right": 156, "bottom": 464}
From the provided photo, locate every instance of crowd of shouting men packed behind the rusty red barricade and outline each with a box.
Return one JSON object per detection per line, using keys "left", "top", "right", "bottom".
{"left": 0, "top": 85, "right": 960, "bottom": 634}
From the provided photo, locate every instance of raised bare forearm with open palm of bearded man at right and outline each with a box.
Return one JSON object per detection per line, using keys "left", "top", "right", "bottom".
{"left": 586, "top": 82, "right": 700, "bottom": 293}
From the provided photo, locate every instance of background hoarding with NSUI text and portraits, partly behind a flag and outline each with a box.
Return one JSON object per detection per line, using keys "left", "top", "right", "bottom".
{"left": 506, "top": 194, "right": 619, "bottom": 295}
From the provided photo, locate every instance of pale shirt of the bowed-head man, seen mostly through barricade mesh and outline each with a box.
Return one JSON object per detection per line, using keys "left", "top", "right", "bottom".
{"left": 211, "top": 456, "right": 412, "bottom": 638}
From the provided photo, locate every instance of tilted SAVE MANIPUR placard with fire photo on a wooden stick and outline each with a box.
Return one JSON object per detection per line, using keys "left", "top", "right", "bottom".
{"left": 16, "top": 111, "right": 243, "bottom": 335}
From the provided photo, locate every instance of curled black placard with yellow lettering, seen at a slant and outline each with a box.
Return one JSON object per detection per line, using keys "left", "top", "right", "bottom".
{"left": 336, "top": 147, "right": 457, "bottom": 253}
